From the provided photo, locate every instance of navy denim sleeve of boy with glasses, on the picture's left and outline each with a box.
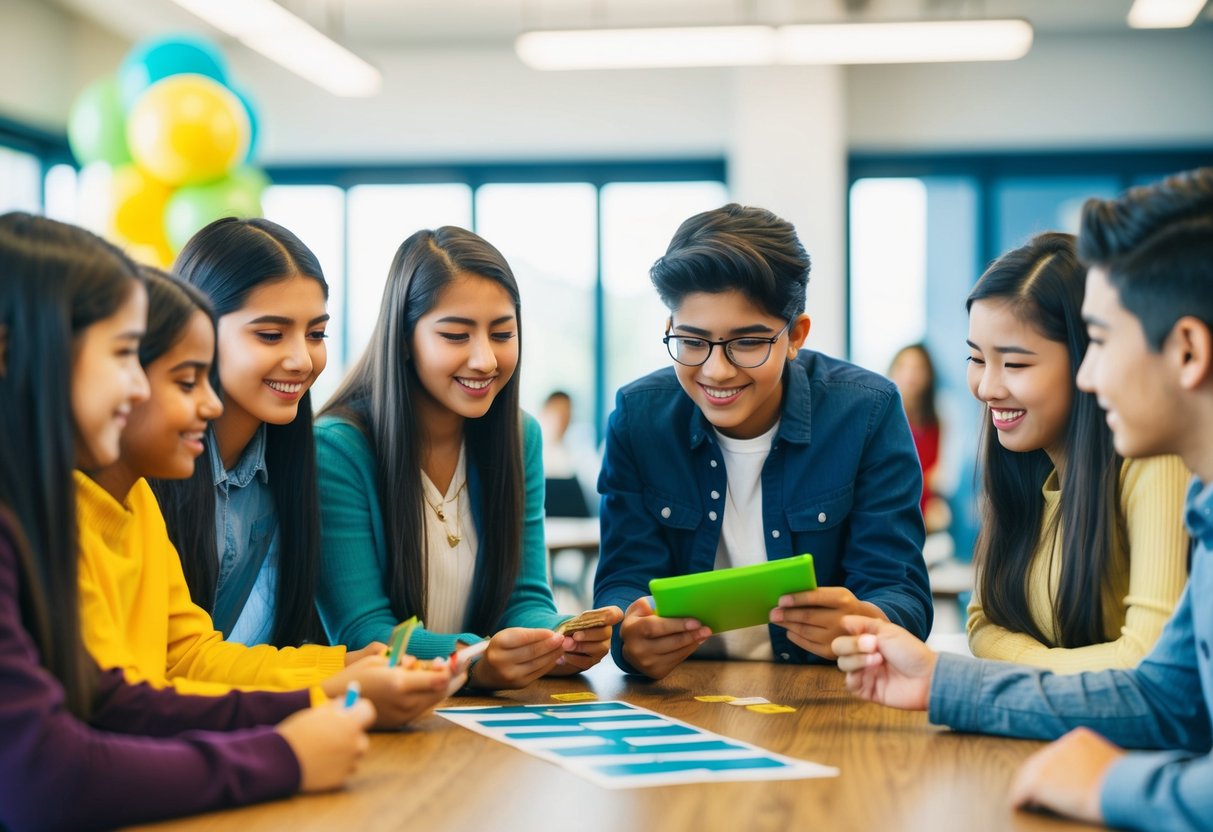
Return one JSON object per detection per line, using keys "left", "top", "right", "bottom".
{"left": 594, "top": 397, "right": 674, "bottom": 673}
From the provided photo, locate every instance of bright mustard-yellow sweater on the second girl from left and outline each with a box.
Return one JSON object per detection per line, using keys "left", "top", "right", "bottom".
{"left": 75, "top": 472, "right": 346, "bottom": 702}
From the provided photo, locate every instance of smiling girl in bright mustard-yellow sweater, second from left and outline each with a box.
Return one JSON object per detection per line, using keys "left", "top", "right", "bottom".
{"left": 76, "top": 269, "right": 450, "bottom": 726}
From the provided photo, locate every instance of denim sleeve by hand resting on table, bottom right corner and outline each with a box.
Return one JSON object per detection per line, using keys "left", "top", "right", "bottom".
{"left": 1099, "top": 751, "right": 1213, "bottom": 832}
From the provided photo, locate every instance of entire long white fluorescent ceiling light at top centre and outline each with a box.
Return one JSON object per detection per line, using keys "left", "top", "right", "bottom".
{"left": 514, "top": 21, "right": 1032, "bottom": 69}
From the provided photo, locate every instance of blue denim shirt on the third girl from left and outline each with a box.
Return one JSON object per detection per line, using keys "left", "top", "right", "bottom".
{"left": 206, "top": 424, "right": 278, "bottom": 644}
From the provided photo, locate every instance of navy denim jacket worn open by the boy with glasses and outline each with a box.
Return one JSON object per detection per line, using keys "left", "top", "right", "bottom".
{"left": 594, "top": 351, "right": 933, "bottom": 672}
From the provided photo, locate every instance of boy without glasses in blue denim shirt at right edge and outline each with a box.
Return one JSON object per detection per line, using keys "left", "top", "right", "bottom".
{"left": 835, "top": 167, "right": 1213, "bottom": 832}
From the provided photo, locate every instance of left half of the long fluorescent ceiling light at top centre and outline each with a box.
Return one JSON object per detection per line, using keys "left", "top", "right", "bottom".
{"left": 514, "top": 25, "right": 775, "bottom": 69}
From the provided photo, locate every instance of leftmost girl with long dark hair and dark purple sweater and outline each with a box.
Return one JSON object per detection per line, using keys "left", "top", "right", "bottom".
{"left": 0, "top": 213, "right": 374, "bottom": 830}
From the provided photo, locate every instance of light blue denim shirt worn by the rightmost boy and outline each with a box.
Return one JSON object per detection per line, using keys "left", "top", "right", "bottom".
{"left": 929, "top": 480, "right": 1213, "bottom": 832}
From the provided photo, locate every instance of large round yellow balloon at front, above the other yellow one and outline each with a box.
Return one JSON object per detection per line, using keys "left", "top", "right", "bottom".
{"left": 126, "top": 75, "right": 249, "bottom": 186}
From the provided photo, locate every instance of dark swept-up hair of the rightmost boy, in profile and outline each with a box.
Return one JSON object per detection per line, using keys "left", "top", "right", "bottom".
{"left": 1078, "top": 167, "right": 1213, "bottom": 352}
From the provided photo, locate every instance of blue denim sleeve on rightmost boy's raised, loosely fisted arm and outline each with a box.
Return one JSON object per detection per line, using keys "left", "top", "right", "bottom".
{"left": 928, "top": 591, "right": 1211, "bottom": 753}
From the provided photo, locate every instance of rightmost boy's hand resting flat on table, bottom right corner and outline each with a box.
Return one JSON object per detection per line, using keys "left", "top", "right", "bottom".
{"left": 1010, "top": 728, "right": 1124, "bottom": 824}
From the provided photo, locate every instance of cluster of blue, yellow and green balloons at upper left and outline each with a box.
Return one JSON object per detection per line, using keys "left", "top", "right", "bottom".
{"left": 68, "top": 35, "right": 269, "bottom": 266}
